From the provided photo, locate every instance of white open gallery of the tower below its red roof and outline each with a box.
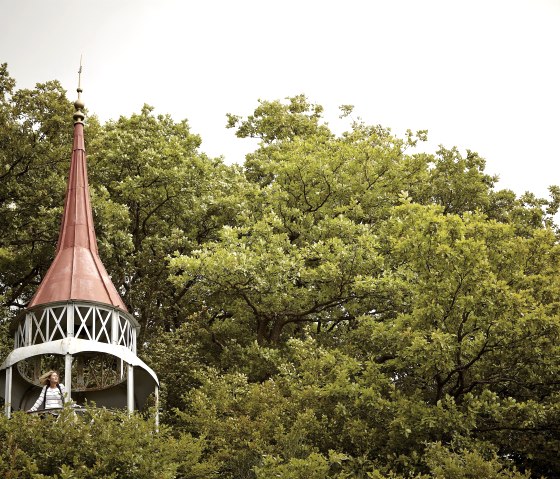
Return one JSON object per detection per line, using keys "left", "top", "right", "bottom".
{"left": 0, "top": 300, "right": 159, "bottom": 410}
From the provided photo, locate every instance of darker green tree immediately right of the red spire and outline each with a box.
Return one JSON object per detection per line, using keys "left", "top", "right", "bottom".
{"left": 89, "top": 106, "right": 245, "bottom": 337}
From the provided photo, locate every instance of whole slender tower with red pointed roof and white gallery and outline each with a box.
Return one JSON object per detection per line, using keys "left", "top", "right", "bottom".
{"left": 0, "top": 66, "right": 159, "bottom": 416}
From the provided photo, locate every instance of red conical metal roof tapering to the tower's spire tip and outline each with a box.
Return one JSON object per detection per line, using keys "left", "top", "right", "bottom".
{"left": 28, "top": 87, "right": 127, "bottom": 311}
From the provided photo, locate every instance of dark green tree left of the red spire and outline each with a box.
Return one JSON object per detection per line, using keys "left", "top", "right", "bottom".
{"left": 0, "top": 64, "right": 72, "bottom": 314}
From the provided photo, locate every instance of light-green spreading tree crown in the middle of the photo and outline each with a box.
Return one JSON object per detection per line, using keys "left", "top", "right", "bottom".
{"left": 171, "top": 96, "right": 427, "bottom": 343}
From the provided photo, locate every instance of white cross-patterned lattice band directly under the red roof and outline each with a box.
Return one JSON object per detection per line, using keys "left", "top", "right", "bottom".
{"left": 14, "top": 302, "right": 137, "bottom": 354}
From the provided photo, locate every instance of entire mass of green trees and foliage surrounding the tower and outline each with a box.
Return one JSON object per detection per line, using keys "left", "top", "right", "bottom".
{"left": 0, "top": 65, "right": 560, "bottom": 479}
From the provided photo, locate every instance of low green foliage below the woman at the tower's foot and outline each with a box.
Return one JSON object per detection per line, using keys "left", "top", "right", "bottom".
{"left": 0, "top": 409, "right": 216, "bottom": 479}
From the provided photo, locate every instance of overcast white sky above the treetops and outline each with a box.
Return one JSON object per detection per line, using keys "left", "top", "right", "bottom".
{"left": 0, "top": 0, "right": 560, "bottom": 199}
